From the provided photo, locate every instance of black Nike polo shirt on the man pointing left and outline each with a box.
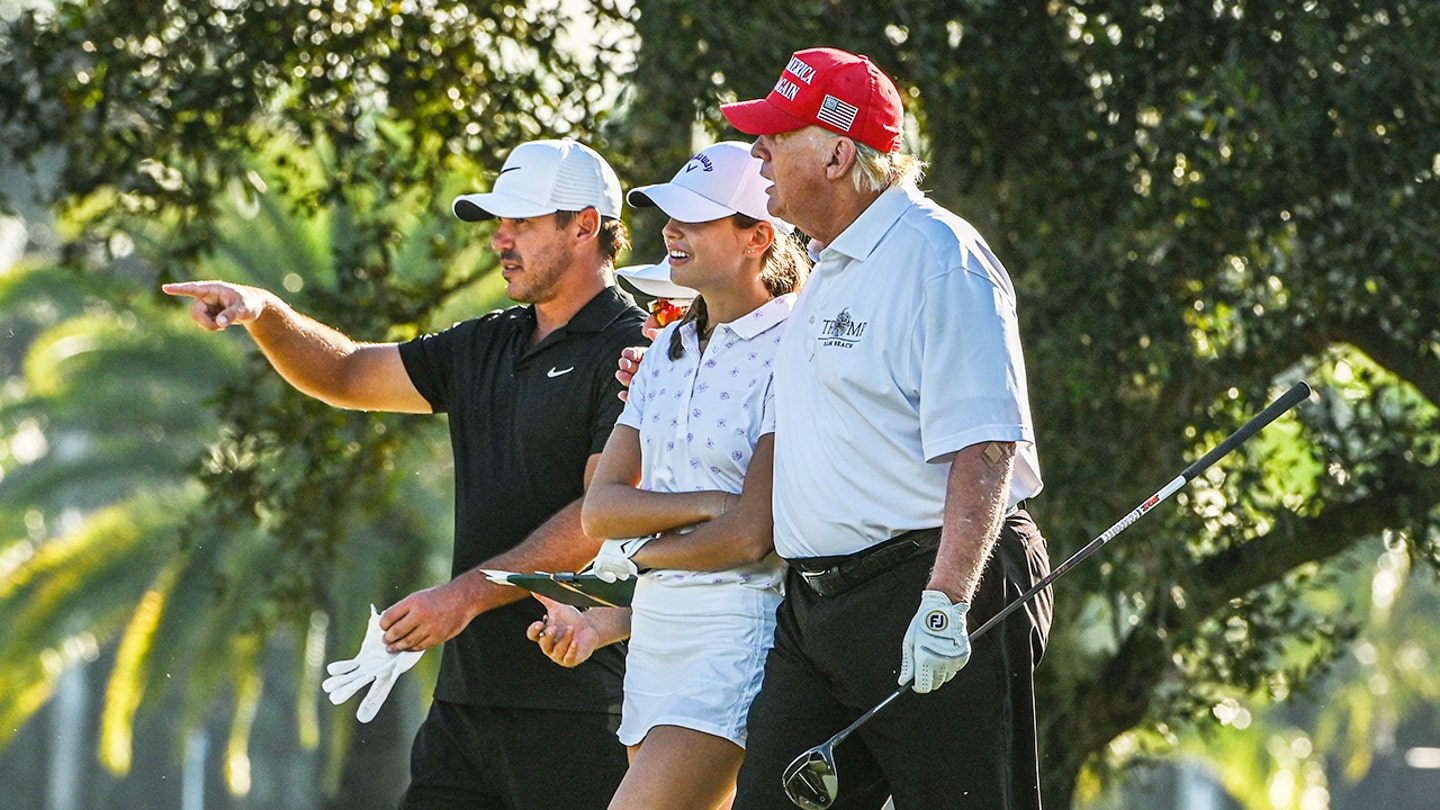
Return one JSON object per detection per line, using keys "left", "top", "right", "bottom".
{"left": 400, "top": 287, "right": 645, "bottom": 711}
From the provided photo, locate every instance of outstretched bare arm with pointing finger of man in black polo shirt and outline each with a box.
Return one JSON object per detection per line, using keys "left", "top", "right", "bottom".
{"left": 161, "top": 281, "right": 431, "bottom": 414}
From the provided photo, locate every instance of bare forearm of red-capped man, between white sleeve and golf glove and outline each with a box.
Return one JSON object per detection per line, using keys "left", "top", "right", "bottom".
{"left": 926, "top": 441, "right": 1015, "bottom": 604}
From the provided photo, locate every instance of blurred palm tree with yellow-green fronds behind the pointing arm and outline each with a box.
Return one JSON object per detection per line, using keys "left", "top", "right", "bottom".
{"left": 0, "top": 132, "right": 495, "bottom": 804}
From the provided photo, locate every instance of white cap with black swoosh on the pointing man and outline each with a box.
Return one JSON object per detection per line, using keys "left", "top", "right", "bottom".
{"left": 452, "top": 138, "right": 621, "bottom": 222}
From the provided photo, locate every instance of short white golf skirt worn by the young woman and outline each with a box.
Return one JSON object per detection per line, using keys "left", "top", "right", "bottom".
{"left": 618, "top": 577, "right": 780, "bottom": 748}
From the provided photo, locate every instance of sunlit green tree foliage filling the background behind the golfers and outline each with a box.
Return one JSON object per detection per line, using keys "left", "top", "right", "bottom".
{"left": 0, "top": 0, "right": 1440, "bottom": 806}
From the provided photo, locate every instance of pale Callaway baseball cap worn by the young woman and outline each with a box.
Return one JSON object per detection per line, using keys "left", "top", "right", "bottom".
{"left": 625, "top": 141, "right": 795, "bottom": 233}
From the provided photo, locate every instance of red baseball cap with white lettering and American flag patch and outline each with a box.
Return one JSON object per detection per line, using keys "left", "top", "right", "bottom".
{"left": 720, "top": 48, "right": 904, "bottom": 151}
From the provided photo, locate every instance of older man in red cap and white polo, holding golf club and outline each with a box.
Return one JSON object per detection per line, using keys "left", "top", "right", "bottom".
{"left": 723, "top": 48, "right": 1051, "bottom": 810}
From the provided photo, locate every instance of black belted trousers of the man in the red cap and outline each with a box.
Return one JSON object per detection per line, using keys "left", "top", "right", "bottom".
{"left": 734, "top": 510, "right": 1054, "bottom": 810}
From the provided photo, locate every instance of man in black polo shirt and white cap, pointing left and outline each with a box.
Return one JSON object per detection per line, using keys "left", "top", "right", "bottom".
{"left": 164, "top": 140, "right": 645, "bottom": 810}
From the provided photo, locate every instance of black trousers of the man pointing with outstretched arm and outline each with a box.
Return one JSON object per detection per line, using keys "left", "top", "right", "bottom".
{"left": 400, "top": 700, "right": 629, "bottom": 810}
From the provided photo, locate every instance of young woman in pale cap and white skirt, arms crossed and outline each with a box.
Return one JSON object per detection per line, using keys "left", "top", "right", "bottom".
{"left": 530, "top": 141, "right": 809, "bottom": 809}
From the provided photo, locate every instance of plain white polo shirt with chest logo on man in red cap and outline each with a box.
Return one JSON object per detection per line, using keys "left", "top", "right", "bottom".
{"left": 775, "top": 189, "right": 1043, "bottom": 558}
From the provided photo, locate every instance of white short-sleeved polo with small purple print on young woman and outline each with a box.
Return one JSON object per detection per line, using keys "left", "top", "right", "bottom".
{"left": 616, "top": 294, "right": 795, "bottom": 589}
